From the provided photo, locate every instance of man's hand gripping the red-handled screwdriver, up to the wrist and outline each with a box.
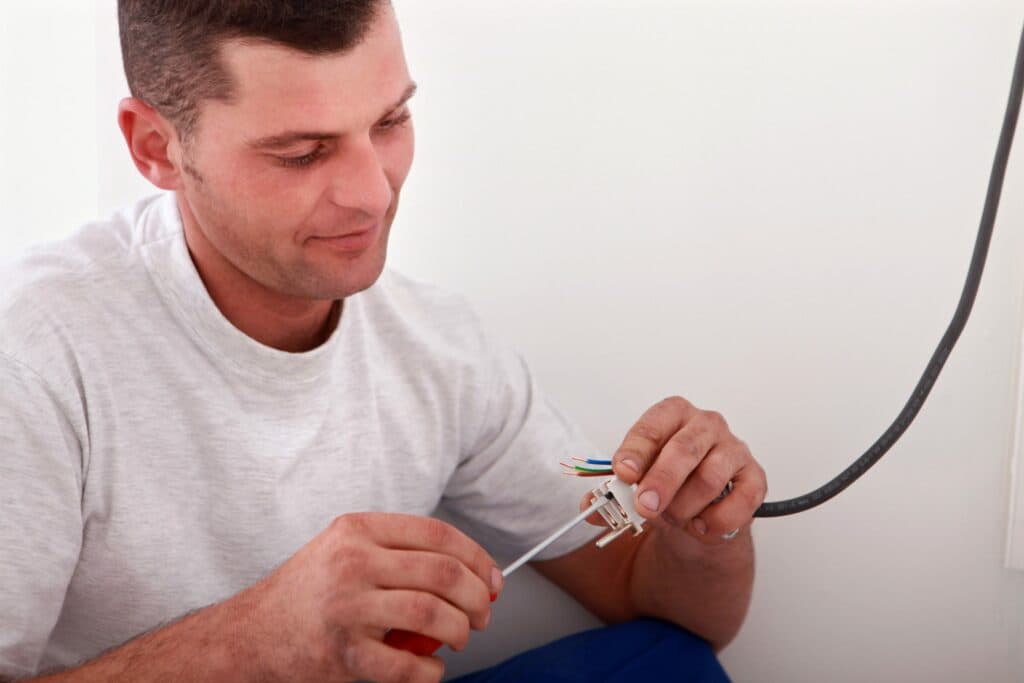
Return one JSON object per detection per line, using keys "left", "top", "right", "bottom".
{"left": 235, "top": 513, "right": 502, "bottom": 681}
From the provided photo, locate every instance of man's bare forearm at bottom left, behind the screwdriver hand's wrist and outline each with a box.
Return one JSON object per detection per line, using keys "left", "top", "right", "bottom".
{"left": 13, "top": 594, "right": 261, "bottom": 683}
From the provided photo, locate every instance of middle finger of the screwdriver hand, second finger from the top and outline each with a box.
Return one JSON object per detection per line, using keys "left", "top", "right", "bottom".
{"left": 371, "top": 550, "right": 490, "bottom": 630}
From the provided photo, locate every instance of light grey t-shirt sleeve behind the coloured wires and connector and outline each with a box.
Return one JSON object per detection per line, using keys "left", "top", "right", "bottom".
{"left": 442, "top": 337, "right": 601, "bottom": 560}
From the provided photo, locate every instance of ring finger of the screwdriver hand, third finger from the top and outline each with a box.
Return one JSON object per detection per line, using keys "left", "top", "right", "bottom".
{"left": 358, "top": 589, "right": 470, "bottom": 651}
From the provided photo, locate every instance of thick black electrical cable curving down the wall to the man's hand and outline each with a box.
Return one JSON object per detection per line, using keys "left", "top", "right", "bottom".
{"left": 754, "top": 21, "right": 1024, "bottom": 517}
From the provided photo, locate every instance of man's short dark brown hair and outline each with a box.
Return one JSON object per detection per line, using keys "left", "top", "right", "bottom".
{"left": 118, "top": 0, "right": 387, "bottom": 139}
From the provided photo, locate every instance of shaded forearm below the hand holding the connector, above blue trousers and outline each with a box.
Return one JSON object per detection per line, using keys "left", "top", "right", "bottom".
{"left": 629, "top": 526, "right": 754, "bottom": 650}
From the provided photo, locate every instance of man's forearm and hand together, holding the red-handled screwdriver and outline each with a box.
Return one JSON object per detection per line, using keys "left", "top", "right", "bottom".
{"left": 25, "top": 513, "right": 502, "bottom": 683}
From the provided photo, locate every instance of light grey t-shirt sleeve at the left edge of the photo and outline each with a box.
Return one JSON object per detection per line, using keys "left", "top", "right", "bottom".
{"left": 0, "top": 353, "right": 82, "bottom": 677}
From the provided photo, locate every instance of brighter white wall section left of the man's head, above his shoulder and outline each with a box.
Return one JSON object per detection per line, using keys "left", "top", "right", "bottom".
{"left": 0, "top": 0, "right": 99, "bottom": 261}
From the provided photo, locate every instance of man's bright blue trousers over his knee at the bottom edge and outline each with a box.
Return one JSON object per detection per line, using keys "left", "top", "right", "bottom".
{"left": 452, "top": 618, "right": 729, "bottom": 683}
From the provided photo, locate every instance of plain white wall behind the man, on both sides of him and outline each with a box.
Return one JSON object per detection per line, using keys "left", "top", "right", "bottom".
{"left": 0, "top": 0, "right": 1024, "bottom": 682}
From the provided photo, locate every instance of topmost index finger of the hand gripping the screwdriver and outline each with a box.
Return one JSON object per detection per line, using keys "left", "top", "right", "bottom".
{"left": 337, "top": 513, "right": 504, "bottom": 594}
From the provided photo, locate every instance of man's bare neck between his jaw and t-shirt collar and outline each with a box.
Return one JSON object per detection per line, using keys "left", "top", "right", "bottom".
{"left": 178, "top": 194, "right": 335, "bottom": 353}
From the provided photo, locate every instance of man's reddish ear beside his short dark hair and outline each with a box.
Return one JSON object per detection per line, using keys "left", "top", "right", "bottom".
{"left": 118, "top": 97, "right": 182, "bottom": 189}
